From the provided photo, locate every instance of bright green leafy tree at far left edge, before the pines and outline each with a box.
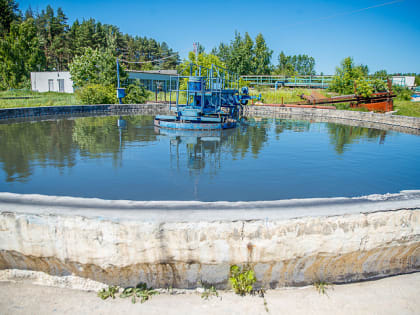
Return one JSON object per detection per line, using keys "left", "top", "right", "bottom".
{"left": 0, "top": 18, "right": 45, "bottom": 89}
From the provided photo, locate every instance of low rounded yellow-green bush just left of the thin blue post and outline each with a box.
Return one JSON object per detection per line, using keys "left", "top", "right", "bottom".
{"left": 76, "top": 84, "right": 117, "bottom": 105}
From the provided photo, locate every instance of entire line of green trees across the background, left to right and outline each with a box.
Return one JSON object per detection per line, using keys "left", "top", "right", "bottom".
{"left": 4, "top": 0, "right": 420, "bottom": 93}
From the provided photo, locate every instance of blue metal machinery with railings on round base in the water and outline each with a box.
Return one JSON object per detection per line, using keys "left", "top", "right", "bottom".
{"left": 155, "top": 63, "right": 256, "bottom": 130}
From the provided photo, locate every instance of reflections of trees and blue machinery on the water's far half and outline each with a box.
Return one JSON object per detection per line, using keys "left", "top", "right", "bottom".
{"left": 0, "top": 116, "right": 387, "bottom": 182}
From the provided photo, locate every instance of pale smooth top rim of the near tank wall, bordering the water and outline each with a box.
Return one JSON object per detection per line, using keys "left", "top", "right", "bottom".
{"left": 0, "top": 190, "right": 420, "bottom": 222}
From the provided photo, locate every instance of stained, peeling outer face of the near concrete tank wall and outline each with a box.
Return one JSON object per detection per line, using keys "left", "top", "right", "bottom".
{"left": 0, "top": 200, "right": 420, "bottom": 288}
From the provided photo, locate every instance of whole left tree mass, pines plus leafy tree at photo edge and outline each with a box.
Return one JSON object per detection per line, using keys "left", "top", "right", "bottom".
{"left": 0, "top": 0, "right": 179, "bottom": 89}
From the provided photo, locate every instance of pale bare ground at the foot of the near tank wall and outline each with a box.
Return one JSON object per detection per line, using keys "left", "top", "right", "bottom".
{"left": 0, "top": 273, "right": 420, "bottom": 315}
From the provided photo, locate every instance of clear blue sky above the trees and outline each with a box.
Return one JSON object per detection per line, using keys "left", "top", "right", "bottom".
{"left": 18, "top": 0, "right": 420, "bottom": 74}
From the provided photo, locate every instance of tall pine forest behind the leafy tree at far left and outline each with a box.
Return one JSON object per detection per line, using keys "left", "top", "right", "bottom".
{"left": 0, "top": 4, "right": 179, "bottom": 76}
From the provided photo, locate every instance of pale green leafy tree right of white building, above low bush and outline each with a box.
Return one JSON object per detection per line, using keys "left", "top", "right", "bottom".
{"left": 69, "top": 47, "right": 127, "bottom": 87}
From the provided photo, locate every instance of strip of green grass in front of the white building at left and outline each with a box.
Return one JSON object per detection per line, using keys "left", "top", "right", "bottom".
{"left": 0, "top": 90, "right": 80, "bottom": 108}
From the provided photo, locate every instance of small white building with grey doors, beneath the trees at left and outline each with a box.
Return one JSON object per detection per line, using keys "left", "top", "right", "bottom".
{"left": 31, "top": 71, "right": 74, "bottom": 93}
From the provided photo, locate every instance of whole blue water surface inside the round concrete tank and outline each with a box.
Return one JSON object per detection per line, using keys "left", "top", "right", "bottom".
{"left": 0, "top": 116, "right": 420, "bottom": 201}
